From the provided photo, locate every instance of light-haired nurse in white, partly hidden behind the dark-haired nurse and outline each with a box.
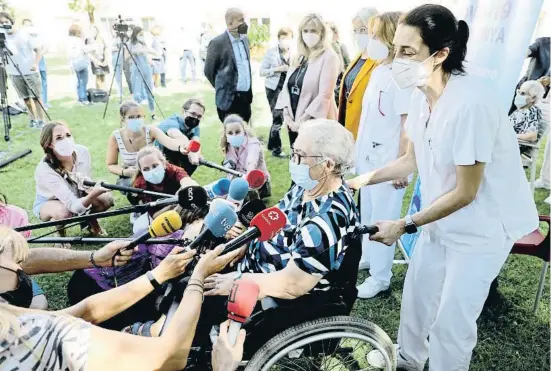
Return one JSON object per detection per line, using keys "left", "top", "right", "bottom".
{"left": 356, "top": 12, "right": 413, "bottom": 299}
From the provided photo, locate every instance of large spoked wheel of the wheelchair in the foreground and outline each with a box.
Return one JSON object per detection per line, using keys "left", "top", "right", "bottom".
{"left": 245, "top": 316, "right": 396, "bottom": 371}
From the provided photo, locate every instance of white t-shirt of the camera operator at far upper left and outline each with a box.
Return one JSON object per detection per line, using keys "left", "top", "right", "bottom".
{"left": 6, "top": 31, "right": 38, "bottom": 75}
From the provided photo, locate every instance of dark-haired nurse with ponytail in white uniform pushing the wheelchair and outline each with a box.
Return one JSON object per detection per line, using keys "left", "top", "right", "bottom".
{"left": 350, "top": 5, "right": 538, "bottom": 371}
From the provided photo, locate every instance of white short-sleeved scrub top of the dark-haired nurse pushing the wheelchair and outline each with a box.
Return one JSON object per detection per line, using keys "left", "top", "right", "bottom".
{"left": 406, "top": 76, "right": 539, "bottom": 248}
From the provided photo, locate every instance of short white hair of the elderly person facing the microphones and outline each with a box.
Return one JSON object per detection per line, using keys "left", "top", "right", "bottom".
{"left": 299, "top": 119, "right": 356, "bottom": 175}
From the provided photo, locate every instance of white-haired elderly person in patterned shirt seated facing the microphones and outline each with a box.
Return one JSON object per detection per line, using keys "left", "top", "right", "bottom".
{"left": 187, "top": 120, "right": 361, "bottom": 364}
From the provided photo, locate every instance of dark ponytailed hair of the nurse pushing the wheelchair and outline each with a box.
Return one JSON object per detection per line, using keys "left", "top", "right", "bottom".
{"left": 400, "top": 4, "right": 469, "bottom": 75}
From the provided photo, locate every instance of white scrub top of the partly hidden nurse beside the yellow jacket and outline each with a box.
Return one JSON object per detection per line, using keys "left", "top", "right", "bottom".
{"left": 356, "top": 64, "right": 413, "bottom": 174}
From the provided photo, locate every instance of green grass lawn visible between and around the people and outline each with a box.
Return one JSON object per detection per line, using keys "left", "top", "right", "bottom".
{"left": 0, "top": 86, "right": 550, "bottom": 371}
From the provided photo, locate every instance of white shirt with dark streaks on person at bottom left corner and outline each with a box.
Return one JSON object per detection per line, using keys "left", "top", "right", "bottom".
{"left": 0, "top": 313, "right": 91, "bottom": 371}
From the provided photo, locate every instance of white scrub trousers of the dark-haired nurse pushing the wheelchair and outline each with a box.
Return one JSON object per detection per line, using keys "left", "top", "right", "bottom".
{"left": 398, "top": 231, "right": 513, "bottom": 371}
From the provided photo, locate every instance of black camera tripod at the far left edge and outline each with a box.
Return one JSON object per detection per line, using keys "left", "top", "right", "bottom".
{"left": 0, "top": 33, "right": 52, "bottom": 142}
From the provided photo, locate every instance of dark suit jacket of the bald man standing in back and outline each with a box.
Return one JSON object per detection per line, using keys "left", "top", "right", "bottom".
{"left": 204, "top": 32, "right": 253, "bottom": 111}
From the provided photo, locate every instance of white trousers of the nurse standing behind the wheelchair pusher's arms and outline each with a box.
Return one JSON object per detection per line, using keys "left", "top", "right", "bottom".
{"left": 360, "top": 182, "right": 406, "bottom": 285}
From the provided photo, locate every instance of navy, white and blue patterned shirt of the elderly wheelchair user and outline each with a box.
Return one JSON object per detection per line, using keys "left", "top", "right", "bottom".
{"left": 239, "top": 185, "right": 359, "bottom": 291}
